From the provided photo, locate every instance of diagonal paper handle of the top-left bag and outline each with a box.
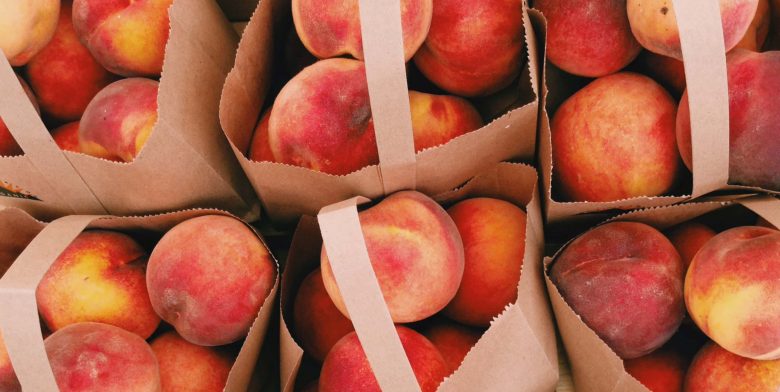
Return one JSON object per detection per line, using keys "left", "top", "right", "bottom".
{"left": 0, "top": 56, "right": 107, "bottom": 214}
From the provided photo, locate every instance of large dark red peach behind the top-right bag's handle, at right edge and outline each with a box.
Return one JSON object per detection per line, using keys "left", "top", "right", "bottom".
{"left": 677, "top": 49, "right": 780, "bottom": 191}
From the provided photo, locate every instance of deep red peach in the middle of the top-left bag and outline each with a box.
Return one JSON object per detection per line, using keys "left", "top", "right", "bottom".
{"left": 27, "top": 1, "right": 115, "bottom": 121}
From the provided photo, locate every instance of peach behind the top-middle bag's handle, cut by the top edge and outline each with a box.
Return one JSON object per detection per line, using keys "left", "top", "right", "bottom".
{"left": 292, "top": 0, "right": 433, "bottom": 61}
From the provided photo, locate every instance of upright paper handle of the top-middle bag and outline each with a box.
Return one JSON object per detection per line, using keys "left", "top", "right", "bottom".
{"left": 360, "top": 0, "right": 417, "bottom": 195}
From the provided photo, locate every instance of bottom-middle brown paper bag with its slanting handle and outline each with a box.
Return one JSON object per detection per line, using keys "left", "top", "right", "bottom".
{"left": 280, "top": 163, "right": 558, "bottom": 392}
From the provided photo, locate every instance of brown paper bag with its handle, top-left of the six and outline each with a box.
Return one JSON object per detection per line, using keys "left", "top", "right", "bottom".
{"left": 0, "top": 0, "right": 259, "bottom": 219}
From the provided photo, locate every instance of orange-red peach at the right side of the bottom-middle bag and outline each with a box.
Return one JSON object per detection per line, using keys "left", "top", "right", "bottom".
{"left": 444, "top": 198, "right": 526, "bottom": 327}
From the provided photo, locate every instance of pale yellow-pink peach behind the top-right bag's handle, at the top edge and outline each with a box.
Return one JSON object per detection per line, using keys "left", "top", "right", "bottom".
{"left": 627, "top": 0, "right": 759, "bottom": 61}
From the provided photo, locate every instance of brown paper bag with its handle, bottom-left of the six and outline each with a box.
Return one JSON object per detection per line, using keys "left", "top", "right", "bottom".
{"left": 0, "top": 209, "right": 279, "bottom": 391}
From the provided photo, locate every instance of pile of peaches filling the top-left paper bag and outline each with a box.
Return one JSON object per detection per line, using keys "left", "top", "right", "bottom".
{"left": 0, "top": 0, "right": 173, "bottom": 162}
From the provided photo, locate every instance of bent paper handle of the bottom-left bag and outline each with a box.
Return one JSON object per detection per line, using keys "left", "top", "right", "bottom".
{"left": 0, "top": 215, "right": 99, "bottom": 392}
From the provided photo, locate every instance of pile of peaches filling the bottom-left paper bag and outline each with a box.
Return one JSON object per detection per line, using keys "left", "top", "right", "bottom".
{"left": 0, "top": 215, "right": 276, "bottom": 392}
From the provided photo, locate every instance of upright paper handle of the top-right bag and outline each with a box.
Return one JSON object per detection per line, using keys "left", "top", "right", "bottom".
{"left": 672, "top": 0, "right": 729, "bottom": 197}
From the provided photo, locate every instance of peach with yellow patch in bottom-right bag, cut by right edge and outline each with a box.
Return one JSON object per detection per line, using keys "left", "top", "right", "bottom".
{"left": 685, "top": 226, "right": 780, "bottom": 360}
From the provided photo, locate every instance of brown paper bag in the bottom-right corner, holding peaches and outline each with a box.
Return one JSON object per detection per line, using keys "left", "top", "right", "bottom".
{"left": 544, "top": 196, "right": 780, "bottom": 392}
